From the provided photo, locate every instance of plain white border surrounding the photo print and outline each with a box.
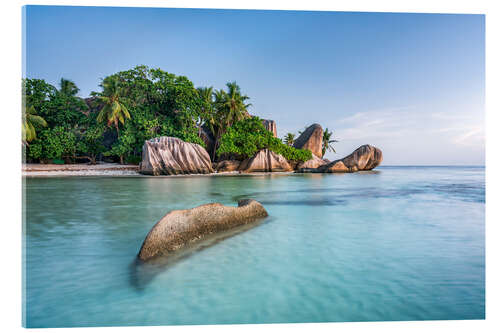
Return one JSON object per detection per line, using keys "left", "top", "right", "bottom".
{"left": 0, "top": 0, "right": 500, "bottom": 333}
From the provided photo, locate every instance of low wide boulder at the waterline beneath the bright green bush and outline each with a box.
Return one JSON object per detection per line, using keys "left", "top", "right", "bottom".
{"left": 238, "top": 149, "right": 293, "bottom": 172}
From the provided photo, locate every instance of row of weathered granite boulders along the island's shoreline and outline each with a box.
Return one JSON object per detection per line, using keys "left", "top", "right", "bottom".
{"left": 139, "top": 120, "right": 382, "bottom": 176}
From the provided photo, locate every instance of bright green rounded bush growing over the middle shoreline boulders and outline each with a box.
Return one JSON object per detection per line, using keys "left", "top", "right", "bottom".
{"left": 217, "top": 117, "right": 312, "bottom": 161}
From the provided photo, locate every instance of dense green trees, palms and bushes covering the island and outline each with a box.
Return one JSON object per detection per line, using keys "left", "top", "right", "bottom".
{"left": 22, "top": 66, "right": 310, "bottom": 163}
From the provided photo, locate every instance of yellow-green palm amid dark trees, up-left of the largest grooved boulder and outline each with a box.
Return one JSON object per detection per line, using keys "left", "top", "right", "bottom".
{"left": 97, "top": 77, "right": 130, "bottom": 137}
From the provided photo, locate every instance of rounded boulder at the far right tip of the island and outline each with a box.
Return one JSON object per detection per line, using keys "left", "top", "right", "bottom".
{"left": 313, "top": 145, "right": 383, "bottom": 173}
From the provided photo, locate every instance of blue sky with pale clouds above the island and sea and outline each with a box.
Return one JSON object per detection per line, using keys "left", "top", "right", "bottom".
{"left": 23, "top": 6, "right": 485, "bottom": 165}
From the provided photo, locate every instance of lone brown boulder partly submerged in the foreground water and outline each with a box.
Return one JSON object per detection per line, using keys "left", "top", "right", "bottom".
{"left": 138, "top": 199, "right": 267, "bottom": 261}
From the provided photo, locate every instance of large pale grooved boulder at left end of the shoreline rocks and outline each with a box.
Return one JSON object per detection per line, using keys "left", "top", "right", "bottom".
{"left": 139, "top": 136, "right": 214, "bottom": 176}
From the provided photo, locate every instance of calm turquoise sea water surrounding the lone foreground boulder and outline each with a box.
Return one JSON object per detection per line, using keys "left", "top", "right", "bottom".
{"left": 24, "top": 167, "right": 485, "bottom": 327}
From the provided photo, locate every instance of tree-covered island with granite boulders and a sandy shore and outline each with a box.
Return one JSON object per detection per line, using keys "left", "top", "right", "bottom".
{"left": 22, "top": 66, "right": 382, "bottom": 176}
